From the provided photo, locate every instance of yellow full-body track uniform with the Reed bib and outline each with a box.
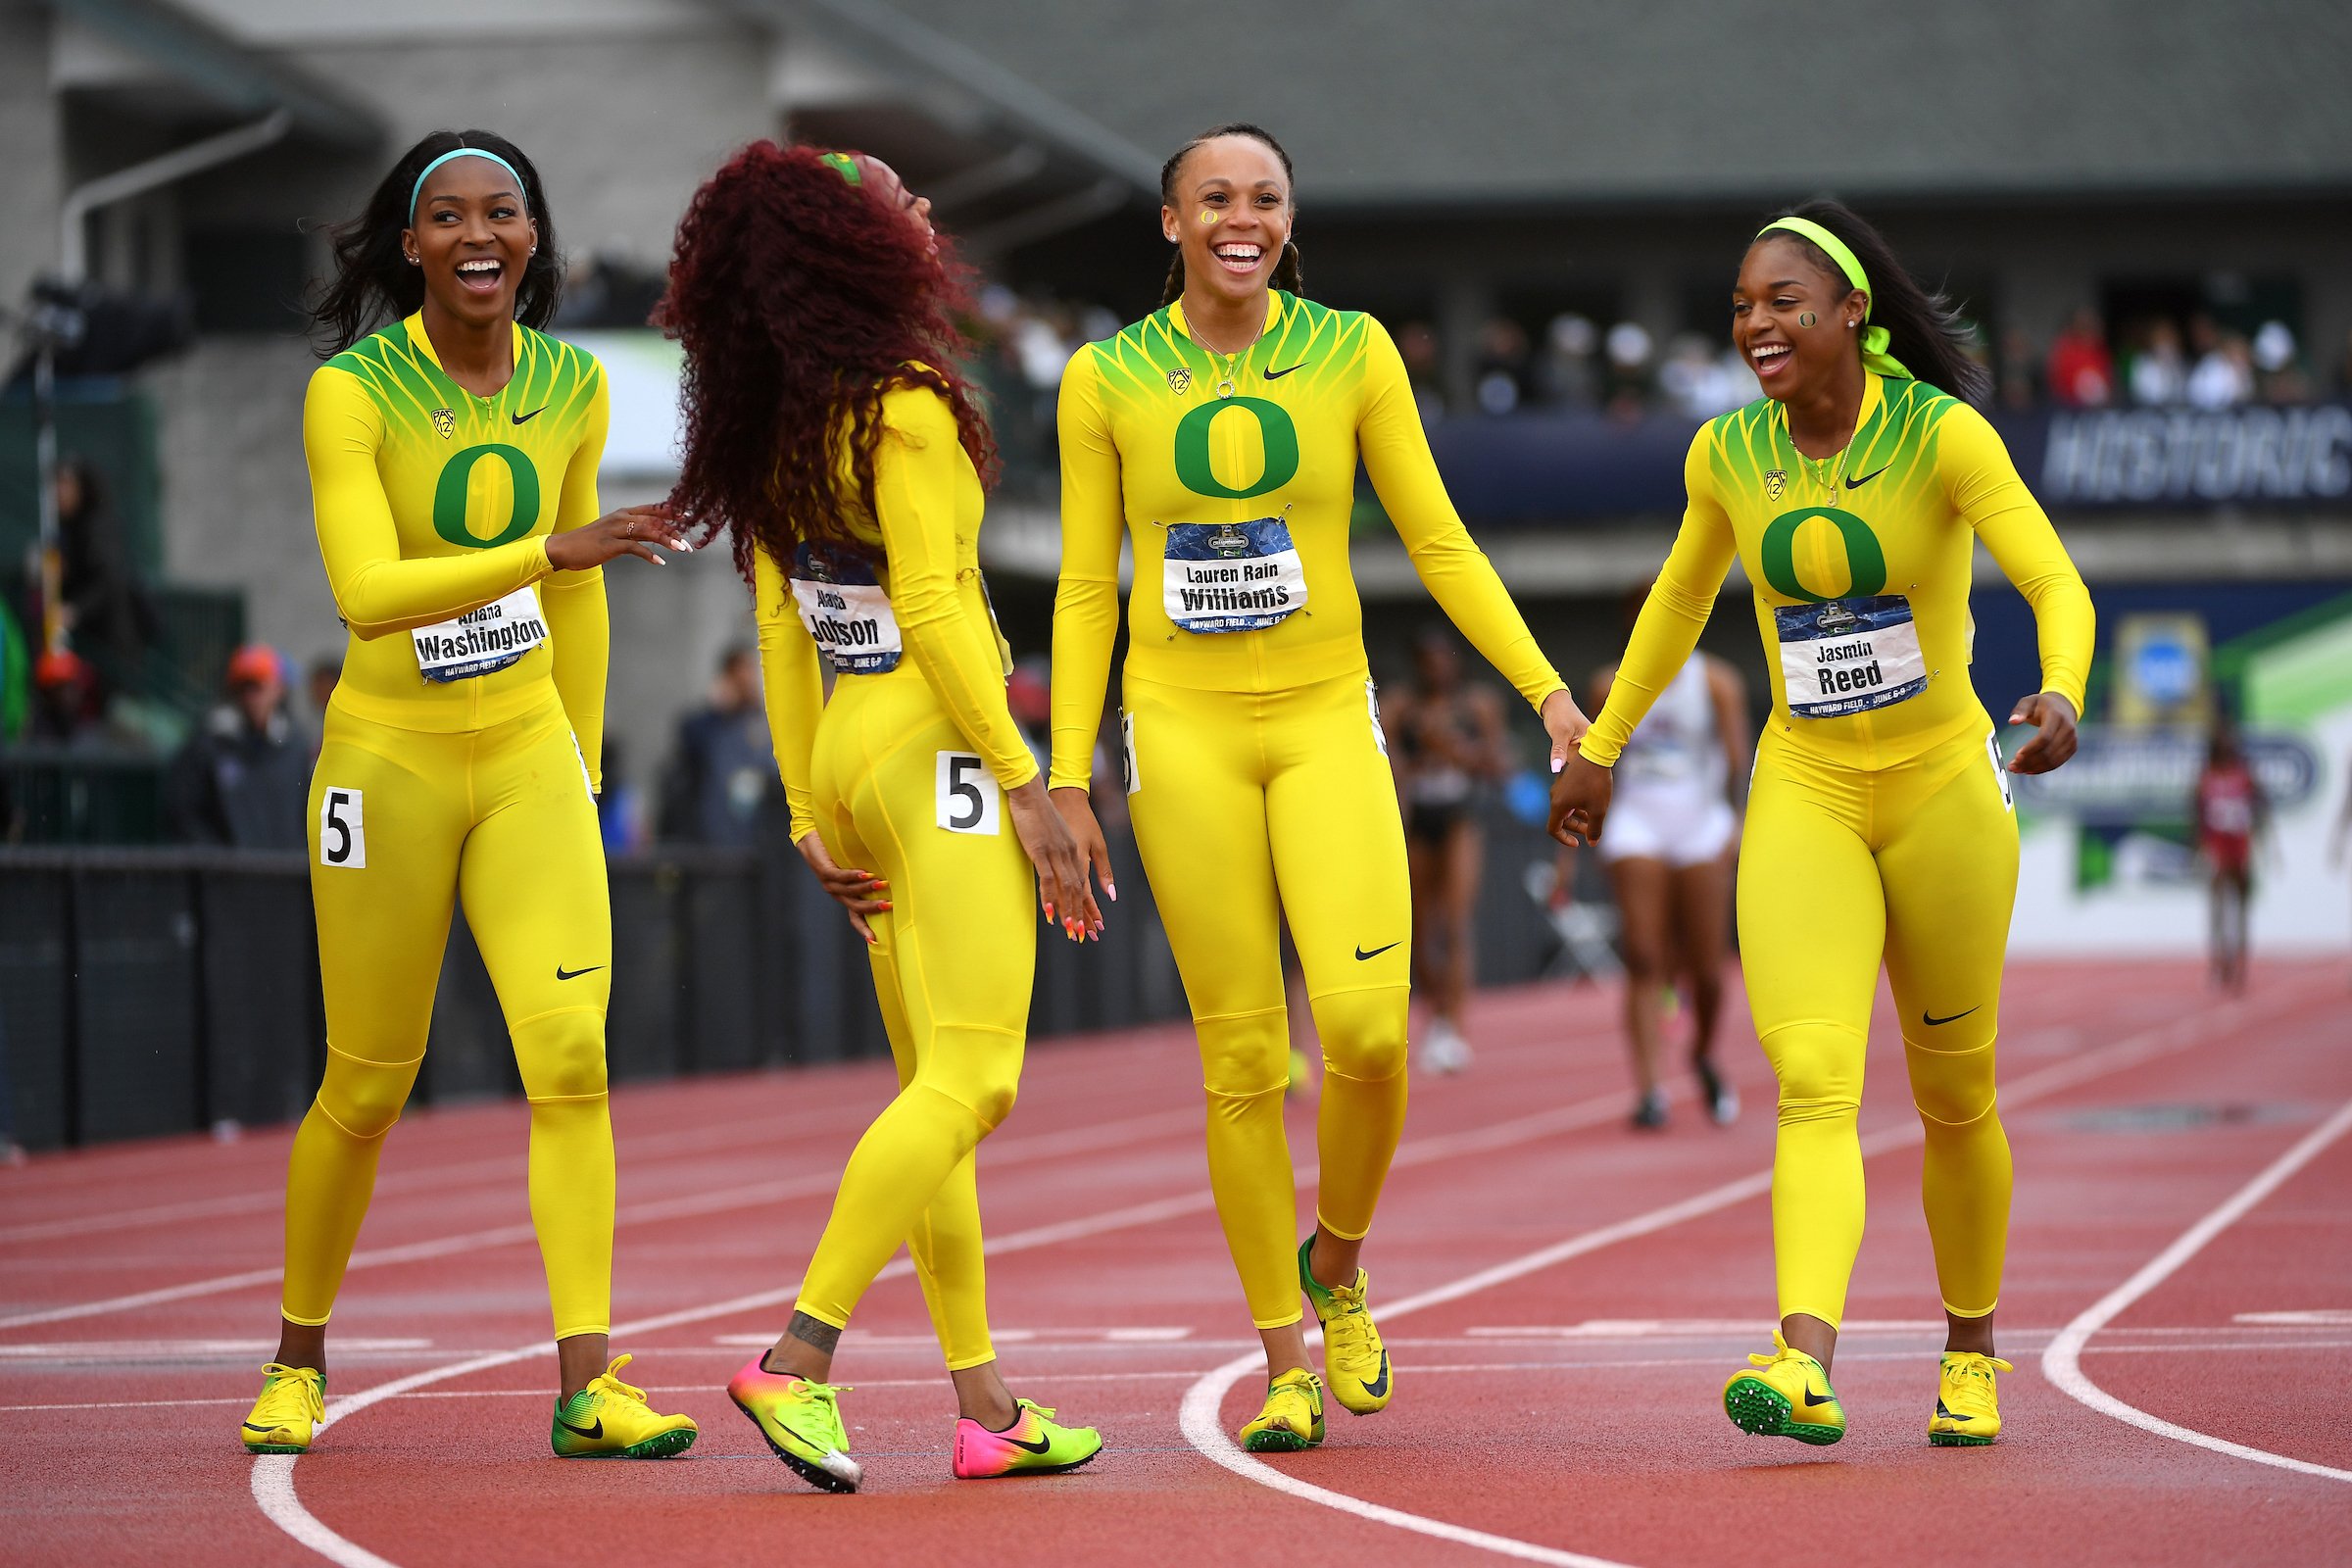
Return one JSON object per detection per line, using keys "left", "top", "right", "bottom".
{"left": 1583, "top": 376, "right": 2093, "bottom": 1324}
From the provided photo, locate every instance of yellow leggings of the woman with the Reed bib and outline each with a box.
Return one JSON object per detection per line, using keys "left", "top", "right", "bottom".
{"left": 1739, "top": 724, "right": 2018, "bottom": 1326}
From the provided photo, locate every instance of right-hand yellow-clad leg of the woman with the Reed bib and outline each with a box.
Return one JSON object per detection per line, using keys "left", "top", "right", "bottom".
{"left": 1880, "top": 738, "right": 2018, "bottom": 1356}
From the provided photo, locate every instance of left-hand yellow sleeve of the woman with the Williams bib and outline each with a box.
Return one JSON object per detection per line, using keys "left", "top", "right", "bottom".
{"left": 1047, "top": 348, "right": 1127, "bottom": 790}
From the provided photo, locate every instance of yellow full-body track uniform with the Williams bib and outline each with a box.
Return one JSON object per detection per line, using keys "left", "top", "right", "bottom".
{"left": 1052, "top": 291, "right": 1562, "bottom": 1328}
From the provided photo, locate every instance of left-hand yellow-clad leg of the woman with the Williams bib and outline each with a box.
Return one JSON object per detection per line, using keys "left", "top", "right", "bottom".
{"left": 1127, "top": 674, "right": 1307, "bottom": 1373}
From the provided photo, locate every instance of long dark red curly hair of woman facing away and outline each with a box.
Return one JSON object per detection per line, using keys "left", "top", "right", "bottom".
{"left": 654, "top": 141, "right": 998, "bottom": 581}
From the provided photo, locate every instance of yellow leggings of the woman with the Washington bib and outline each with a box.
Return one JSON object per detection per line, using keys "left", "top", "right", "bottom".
{"left": 284, "top": 698, "right": 613, "bottom": 1338}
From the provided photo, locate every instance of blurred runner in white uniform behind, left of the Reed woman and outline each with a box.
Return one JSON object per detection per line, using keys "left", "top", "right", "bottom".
{"left": 1594, "top": 654, "right": 1750, "bottom": 1128}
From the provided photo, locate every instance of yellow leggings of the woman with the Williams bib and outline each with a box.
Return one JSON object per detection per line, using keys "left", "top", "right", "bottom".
{"left": 1124, "top": 672, "right": 1413, "bottom": 1328}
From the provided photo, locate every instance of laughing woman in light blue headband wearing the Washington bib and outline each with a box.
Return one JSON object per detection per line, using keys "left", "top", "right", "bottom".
{"left": 242, "top": 131, "right": 694, "bottom": 1460}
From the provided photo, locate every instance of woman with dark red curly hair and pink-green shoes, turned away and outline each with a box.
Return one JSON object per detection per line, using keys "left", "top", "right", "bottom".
{"left": 661, "top": 141, "right": 1103, "bottom": 1493}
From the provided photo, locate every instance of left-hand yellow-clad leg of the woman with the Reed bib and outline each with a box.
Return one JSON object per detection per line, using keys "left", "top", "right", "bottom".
{"left": 1739, "top": 753, "right": 1886, "bottom": 1366}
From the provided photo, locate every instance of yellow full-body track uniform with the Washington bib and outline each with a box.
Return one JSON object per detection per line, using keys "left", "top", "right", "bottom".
{"left": 284, "top": 315, "right": 613, "bottom": 1338}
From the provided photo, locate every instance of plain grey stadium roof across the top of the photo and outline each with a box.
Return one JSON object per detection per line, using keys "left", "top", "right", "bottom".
{"left": 795, "top": 0, "right": 2352, "bottom": 207}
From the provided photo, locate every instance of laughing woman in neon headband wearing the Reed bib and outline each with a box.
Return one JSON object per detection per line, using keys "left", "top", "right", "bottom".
{"left": 1552, "top": 202, "right": 2091, "bottom": 1446}
